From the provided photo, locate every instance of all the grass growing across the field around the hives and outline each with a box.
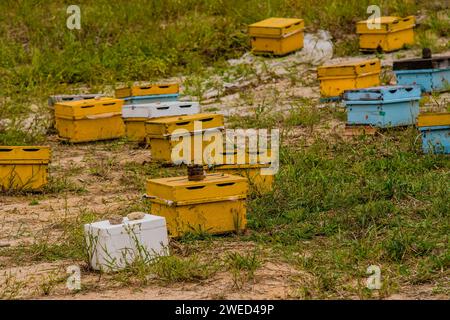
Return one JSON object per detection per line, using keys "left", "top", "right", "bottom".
{"left": 0, "top": 0, "right": 450, "bottom": 298}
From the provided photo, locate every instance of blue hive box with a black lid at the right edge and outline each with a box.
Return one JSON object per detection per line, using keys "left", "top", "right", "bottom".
{"left": 393, "top": 54, "right": 450, "bottom": 92}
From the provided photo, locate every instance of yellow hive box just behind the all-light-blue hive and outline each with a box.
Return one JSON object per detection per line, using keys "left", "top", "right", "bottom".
{"left": 317, "top": 59, "right": 381, "bottom": 97}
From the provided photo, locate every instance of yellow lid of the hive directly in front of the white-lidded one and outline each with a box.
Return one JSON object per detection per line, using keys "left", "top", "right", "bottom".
{"left": 145, "top": 113, "right": 224, "bottom": 137}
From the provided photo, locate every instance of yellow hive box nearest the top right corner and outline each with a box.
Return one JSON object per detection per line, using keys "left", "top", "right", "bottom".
{"left": 356, "top": 16, "right": 415, "bottom": 52}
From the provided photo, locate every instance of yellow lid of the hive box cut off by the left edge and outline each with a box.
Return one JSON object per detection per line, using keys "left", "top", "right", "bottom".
{"left": 0, "top": 146, "right": 50, "bottom": 162}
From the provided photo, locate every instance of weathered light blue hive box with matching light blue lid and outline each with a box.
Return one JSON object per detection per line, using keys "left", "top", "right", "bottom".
{"left": 344, "top": 86, "right": 421, "bottom": 128}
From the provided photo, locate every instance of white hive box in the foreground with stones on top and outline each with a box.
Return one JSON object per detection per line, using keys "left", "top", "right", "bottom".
{"left": 84, "top": 214, "right": 169, "bottom": 272}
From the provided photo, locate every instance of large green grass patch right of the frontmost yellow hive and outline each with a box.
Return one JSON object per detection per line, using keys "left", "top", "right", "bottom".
{"left": 249, "top": 129, "right": 450, "bottom": 296}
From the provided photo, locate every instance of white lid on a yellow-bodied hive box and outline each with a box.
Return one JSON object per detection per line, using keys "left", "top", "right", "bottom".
{"left": 122, "top": 101, "right": 200, "bottom": 118}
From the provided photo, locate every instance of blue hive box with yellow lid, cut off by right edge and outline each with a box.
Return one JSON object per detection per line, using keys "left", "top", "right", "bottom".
{"left": 417, "top": 113, "right": 450, "bottom": 154}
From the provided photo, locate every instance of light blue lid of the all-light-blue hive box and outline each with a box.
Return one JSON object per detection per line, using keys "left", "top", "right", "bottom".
{"left": 344, "top": 86, "right": 421, "bottom": 103}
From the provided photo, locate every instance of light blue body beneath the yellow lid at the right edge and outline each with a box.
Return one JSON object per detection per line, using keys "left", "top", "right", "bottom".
{"left": 419, "top": 125, "right": 450, "bottom": 154}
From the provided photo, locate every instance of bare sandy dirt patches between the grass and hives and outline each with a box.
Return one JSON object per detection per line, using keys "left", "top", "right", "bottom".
{"left": 0, "top": 47, "right": 450, "bottom": 300}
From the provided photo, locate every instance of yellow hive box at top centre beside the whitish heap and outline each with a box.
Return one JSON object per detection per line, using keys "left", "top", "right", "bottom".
{"left": 248, "top": 18, "right": 305, "bottom": 56}
